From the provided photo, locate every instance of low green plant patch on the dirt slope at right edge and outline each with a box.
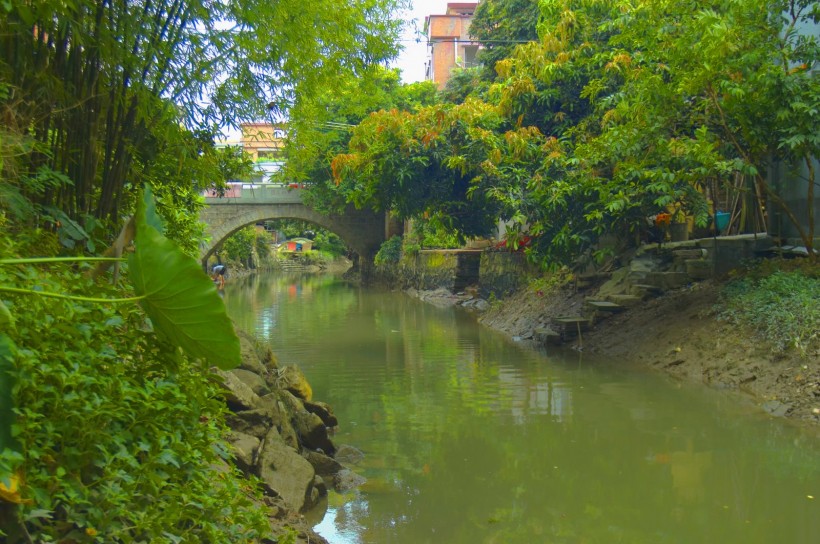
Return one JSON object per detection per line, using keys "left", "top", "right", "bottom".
{"left": 718, "top": 263, "right": 820, "bottom": 356}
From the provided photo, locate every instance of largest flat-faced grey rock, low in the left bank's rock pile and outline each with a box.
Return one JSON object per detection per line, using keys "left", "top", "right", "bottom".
{"left": 256, "top": 429, "right": 316, "bottom": 512}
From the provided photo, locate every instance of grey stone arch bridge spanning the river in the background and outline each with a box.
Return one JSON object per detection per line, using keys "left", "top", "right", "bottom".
{"left": 199, "top": 184, "right": 396, "bottom": 272}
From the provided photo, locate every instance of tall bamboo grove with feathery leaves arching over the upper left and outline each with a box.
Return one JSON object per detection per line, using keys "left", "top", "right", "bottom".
{"left": 0, "top": 0, "right": 406, "bottom": 242}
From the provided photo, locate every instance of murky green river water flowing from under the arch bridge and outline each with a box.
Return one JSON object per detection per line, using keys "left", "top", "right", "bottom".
{"left": 224, "top": 276, "right": 820, "bottom": 544}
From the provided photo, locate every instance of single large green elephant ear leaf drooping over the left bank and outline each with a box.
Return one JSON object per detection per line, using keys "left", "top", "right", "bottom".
{"left": 128, "top": 185, "right": 241, "bottom": 369}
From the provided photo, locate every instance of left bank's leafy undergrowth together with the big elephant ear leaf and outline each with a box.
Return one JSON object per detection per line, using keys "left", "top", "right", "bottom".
{"left": 0, "top": 186, "right": 269, "bottom": 542}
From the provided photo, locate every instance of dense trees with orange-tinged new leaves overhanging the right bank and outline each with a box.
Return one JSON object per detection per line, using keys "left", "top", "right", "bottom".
{"left": 324, "top": 0, "right": 820, "bottom": 265}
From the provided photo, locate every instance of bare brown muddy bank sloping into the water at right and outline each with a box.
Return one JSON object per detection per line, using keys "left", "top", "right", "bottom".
{"left": 480, "top": 281, "right": 820, "bottom": 425}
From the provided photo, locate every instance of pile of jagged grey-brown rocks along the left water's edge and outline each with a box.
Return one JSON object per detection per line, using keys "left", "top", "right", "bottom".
{"left": 217, "top": 333, "right": 364, "bottom": 544}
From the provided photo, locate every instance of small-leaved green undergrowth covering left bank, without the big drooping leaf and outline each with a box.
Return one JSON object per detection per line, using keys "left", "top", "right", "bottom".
{"left": 0, "top": 266, "right": 267, "bottom": 543}
